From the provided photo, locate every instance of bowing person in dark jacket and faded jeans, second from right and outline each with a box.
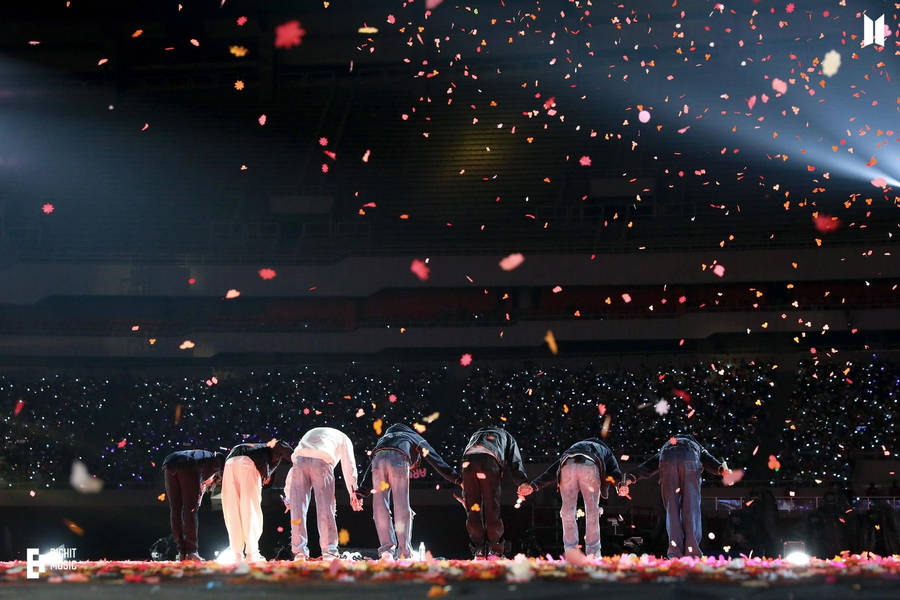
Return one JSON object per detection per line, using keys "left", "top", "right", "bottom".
{"left": 518, "top": 438, "right": 622, "bottom": 557}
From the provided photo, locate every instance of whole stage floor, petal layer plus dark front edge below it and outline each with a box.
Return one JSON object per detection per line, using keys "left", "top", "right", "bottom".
{"left": 0, "top": 555, "right": 900, "bottom": 600}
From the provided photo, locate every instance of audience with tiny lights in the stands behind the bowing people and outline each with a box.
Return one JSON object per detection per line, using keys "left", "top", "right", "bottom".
{"left": 0, "top": 360, "right": 900, "bottom": 489}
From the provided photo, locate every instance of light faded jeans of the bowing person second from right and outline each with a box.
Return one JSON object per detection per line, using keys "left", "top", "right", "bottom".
{"left": 559, "top": 460, "right": 601, "bottom": 556}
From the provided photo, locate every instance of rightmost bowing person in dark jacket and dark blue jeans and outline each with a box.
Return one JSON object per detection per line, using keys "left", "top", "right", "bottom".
{"left": 618, "top": 434, "right": 730, "bottom": 558}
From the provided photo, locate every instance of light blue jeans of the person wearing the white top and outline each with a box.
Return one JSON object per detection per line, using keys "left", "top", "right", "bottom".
{"left": 288, "top": 456, "right": 338, "bottom": 557}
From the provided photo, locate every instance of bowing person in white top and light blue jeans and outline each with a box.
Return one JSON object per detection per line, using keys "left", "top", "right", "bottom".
{"left": 284, "top": 427, "right": 362, "bottom": 560}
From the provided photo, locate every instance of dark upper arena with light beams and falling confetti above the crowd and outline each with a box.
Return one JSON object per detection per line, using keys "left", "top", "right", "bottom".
{"left": 0, "top": 0, "right": 900, "bottom": 355}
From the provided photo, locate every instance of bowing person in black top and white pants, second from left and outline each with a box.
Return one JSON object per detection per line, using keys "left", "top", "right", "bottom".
{"left": 222, "top": 442, "right": 291, "bottom": 562}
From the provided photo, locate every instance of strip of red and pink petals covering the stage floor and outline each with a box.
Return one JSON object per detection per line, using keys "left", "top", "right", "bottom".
{"left": 0, "top": 555, "right": 900, "bottom": 584}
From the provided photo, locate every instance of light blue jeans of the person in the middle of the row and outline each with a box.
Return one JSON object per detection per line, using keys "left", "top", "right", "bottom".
{"left": 372, "top": 450, "right": 415, "bottom": 558}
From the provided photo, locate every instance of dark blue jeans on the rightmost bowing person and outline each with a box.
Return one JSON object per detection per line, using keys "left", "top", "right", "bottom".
{"left": 659, "top": 445, "right": 703, "bottom": 558}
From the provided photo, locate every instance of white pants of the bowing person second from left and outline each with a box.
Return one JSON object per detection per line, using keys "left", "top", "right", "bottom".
{"left": 222, "top": 456, "right": 263, "bottom": 560}
